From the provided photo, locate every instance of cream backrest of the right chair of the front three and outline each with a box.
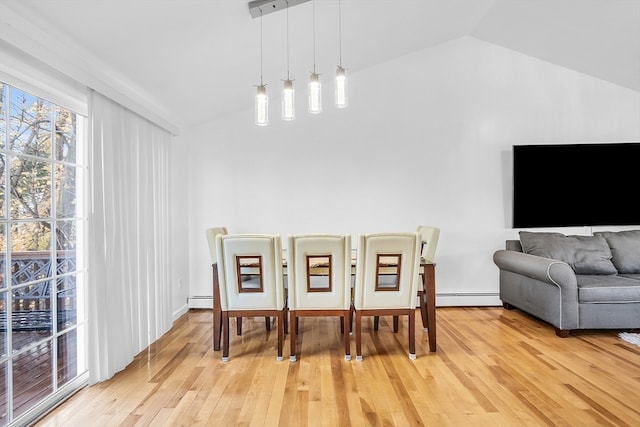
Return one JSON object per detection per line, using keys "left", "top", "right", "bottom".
{"left": 354, "top": 232, "right": 421, "bottom": 310}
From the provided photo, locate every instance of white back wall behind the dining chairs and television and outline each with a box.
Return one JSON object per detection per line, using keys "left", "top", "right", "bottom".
{"left": 184, "top": 37, "right": 640, "bottom": 306}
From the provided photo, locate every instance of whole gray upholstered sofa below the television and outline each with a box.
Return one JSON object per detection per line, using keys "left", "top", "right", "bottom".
{"left": 493, "top": 230, "right": 640, "bottom": 337}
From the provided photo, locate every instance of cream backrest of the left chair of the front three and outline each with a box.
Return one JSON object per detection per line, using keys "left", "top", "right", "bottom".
{"left": 216, "top": 234, "right": 284, "bottom": 311}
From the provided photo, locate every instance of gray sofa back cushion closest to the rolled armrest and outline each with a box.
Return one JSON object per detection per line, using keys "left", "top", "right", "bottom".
{"left": 520, "top": 231, "right": 618, "bottom": 274}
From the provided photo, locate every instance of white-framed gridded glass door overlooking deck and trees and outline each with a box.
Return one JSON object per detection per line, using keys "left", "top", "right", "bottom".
{"left": 0, "top": 82, "right": 86, "bottom": 425}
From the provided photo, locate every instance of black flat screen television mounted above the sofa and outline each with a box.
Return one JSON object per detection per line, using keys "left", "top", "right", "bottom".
{"left": 513, "top": 142, "right": 640, "bottom": 228}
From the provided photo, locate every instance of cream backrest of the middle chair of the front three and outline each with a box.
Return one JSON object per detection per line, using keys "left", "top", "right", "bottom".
{"left": 287, "top": 234, "right": 351, "bottom": 310}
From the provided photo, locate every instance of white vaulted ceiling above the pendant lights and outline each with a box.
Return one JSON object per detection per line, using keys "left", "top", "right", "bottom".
{"left": 0, "top": 0, "right": 640, "bottom": 130}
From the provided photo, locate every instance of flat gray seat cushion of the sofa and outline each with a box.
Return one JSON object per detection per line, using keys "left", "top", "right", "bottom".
{"left": 576, "top": 274, "right": 640, "bottom": 303}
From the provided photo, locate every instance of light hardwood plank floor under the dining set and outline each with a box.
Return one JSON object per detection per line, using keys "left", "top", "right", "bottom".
{"left": 36, "top": 307, "right": 640, "bottom": 427}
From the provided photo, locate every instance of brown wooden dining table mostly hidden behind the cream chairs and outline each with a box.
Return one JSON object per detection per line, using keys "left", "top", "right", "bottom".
{"left": 211, "top": 256, "right": 436, "bottom": 352}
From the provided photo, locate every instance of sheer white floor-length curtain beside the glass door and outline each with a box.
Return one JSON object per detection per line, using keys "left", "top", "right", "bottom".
{"left": 87, "top": 91, "right": 172, "bottom": 384}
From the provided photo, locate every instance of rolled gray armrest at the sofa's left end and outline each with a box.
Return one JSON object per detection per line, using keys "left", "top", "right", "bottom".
{"left": 493, "top": 249, "right": 579, "bottom": 333}
